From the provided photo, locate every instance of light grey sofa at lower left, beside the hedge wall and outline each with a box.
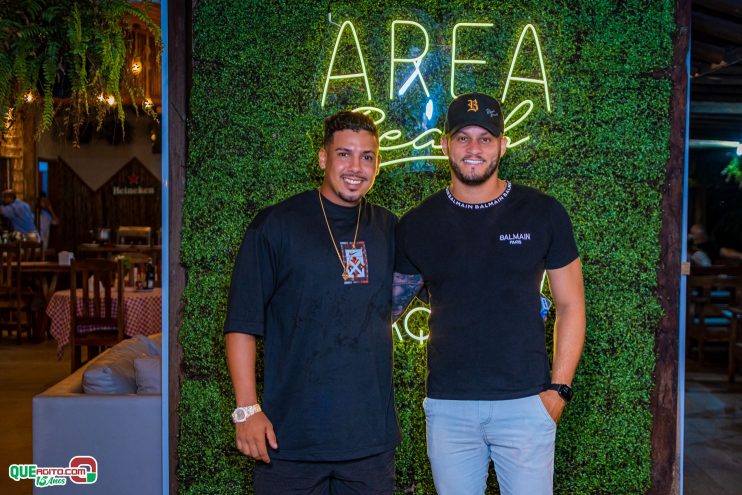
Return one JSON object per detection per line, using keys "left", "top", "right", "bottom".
{"left": 33, "top": 338, "right": 162, "bottom": 495}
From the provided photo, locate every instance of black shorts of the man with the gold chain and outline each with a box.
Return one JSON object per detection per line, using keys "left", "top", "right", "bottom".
{"left": 254, "top": 450, "right": 394, "bottom": 495}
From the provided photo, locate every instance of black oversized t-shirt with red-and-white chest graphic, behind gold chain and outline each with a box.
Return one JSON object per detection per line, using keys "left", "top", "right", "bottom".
{"left": 224, "top": 190, "right": 399, "bottom": 461}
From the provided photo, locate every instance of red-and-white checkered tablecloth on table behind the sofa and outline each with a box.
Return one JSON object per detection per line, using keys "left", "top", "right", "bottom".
{"left": 46, "top": 287, "right": 162, "bottom": 359}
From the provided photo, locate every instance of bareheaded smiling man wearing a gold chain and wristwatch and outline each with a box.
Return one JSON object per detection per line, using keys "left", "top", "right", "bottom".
{"left": 224, "top": 112, "right": 400, "bottom": 495}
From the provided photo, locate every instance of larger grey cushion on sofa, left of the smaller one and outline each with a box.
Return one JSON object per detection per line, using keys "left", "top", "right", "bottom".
{"left": 82, "top": 335, "right": 158, "bottom": 394}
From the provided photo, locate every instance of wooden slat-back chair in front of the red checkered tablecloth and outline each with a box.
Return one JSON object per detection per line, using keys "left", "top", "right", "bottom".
{"left": 70, "top": 259, "right": 124, "bottom": 373}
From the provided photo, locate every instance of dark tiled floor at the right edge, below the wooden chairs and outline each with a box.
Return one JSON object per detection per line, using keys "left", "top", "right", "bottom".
{"left": 683, "top": 360, "right": 742, "bottom": 495}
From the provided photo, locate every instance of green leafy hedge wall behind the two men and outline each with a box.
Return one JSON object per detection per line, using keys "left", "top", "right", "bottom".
{"left": 182, "top": 0, "right": 676, "bottom": 495}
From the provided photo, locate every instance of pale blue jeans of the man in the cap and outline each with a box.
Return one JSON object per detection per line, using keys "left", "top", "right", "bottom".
{"left": 423, "top": 395, "right": 556, "bottom": 495}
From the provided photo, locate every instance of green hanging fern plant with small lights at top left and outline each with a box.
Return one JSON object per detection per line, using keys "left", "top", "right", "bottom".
{"left": 0, "top": 0, "right": 162, "bottom": 146}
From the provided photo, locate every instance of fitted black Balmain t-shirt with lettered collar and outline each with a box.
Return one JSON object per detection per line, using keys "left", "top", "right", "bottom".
{"left": 395, "top": 183, "right": 578, "bottom": 400}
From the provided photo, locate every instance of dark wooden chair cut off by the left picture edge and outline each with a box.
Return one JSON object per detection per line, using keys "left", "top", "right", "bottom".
{"left": 0, "top": 243, "right": 33, "bottom": 344}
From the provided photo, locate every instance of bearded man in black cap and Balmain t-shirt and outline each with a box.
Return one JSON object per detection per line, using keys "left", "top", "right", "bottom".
{"left": 393, "top": 93, "right": 585, "bottom": 495}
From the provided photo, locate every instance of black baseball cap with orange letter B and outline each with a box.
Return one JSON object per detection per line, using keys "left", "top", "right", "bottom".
{"left": 445, "top": 93, "right": 505, "bottom": 137}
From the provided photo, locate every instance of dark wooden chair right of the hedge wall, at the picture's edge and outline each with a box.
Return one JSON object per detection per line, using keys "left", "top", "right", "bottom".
{"left": 686, "top": 275, "right": 739, "bottom": 364}
